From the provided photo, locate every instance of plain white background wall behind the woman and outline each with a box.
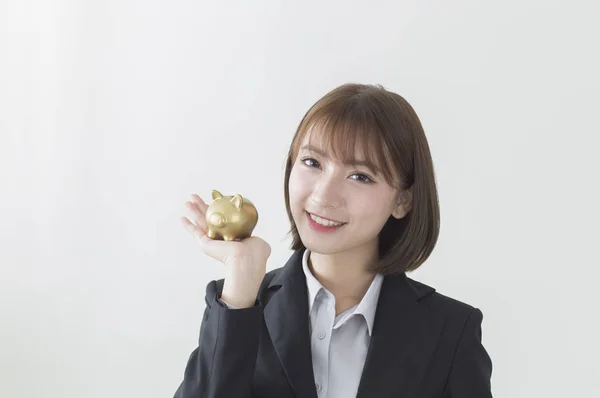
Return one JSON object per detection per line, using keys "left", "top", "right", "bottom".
{"left": 0, "top": 0, "right": 600, "bottom": 398}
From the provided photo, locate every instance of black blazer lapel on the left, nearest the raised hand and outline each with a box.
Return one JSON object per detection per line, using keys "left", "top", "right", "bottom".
{"left": 264, "top": 250, "right": 317, "bottom": 398}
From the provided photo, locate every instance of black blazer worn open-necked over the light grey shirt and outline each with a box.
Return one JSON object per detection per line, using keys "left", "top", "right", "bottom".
{"left": 175, "top": 250, "right": 492, "bottom": 398}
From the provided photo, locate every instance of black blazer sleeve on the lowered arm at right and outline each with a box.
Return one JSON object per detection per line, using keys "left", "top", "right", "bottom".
{"left": 444, "top": 308, "right": 492, "bottom": 398}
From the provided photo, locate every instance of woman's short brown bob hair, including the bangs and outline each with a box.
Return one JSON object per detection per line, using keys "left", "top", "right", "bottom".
{"left": 284, "top": 83, "right": 440, "bottom": 275}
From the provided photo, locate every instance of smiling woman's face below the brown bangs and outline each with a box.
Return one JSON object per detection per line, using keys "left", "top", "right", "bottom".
{"left": 289, "top": 134, "right": 409, "bottom": 254}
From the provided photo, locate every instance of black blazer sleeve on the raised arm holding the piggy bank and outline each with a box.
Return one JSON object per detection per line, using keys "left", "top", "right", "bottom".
{"left": 174, "top": 280, "right": 263, "bottom": 398}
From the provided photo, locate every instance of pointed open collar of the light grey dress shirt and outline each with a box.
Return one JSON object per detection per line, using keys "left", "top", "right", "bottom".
{"left": 302, "top": 249, "right": 383, "bottom": 336}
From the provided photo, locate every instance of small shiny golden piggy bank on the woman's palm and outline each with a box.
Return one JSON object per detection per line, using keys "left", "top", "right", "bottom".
{"left": 206, "top": 189, "right": 258, "bottom": 240}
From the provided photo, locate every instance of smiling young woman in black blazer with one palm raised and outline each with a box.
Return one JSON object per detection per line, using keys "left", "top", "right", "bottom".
{"left": 175, "top": 84, "right": 492, "bottom": 398}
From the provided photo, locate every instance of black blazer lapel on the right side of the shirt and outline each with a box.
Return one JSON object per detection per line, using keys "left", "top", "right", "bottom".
{"left": 357, "top": 273, "right": 443, "bottom": 398}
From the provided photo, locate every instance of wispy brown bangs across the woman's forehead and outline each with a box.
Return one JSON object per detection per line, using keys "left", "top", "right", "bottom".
{"left": 293, "top": 106, "right": 399, "bottom": 188}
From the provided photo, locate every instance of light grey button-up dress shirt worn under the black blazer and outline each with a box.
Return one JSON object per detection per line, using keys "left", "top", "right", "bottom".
{"left": 221, "top": 249, "right": 383, "bottom": 398}
